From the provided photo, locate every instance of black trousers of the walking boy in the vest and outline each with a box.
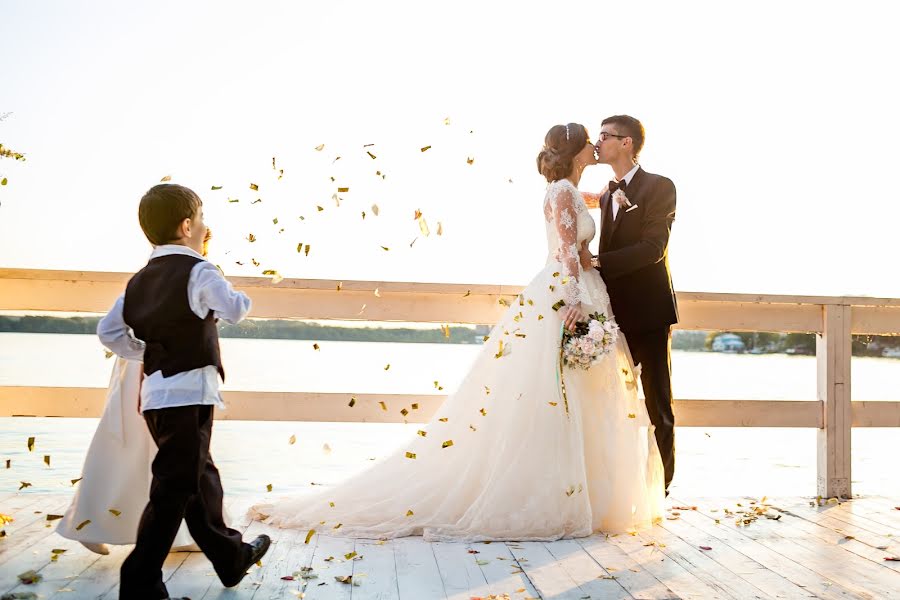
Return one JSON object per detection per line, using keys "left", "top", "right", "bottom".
{"left": 119, "top": 405, "right": 250, "bottom": 600}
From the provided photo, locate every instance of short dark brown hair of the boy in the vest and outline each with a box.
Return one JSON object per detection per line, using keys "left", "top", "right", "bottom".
{"left": 138, "top": 183, "right": 203, "bottom": 246}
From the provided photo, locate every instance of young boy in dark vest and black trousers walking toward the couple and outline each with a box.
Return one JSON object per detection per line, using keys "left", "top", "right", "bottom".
{"left": 97, "top": 184, "right": 271, "bottom": 600}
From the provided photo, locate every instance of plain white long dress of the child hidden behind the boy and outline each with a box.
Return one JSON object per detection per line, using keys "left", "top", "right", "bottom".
{"left": 56, "top": 358, "right": 199, "bottom": 550}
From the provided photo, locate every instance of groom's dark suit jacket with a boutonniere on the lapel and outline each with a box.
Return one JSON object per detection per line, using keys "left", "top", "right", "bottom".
{"left": 597, "top": 167, "right": 678, "bottom": 335}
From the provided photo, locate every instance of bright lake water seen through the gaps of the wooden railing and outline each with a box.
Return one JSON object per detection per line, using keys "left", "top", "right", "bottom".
{"left": 0, "top": 333, "right": 900, "bottom": 496}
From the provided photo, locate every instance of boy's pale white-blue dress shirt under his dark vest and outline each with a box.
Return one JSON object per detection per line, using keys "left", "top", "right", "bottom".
{"left": 97, "top": 244, "right": 250, "bottom": 412}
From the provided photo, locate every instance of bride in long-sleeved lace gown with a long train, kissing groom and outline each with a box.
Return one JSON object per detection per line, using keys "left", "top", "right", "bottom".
{"left": 250, "top": 123, "right": 664, "bottom": 541}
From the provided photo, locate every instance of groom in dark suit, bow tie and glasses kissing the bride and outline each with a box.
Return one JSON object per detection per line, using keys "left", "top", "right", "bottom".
{"left": 594, "top": 115, "right": 678, "bottom": 495}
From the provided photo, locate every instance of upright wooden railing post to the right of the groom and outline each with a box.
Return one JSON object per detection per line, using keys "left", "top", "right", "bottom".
{"left": 816, "top": 304, "right": 853, "bottom": 498}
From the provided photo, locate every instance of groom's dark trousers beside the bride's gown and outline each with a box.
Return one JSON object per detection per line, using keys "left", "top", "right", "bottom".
{"left": 625, "top": 327, "right": 675, "bottom": 494}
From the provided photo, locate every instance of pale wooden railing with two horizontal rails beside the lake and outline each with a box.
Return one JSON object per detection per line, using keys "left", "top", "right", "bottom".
{"left": 0, "top": 269, "right": 900, "bottom": 497}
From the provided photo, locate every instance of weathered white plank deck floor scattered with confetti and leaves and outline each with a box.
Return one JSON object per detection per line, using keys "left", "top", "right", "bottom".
{"left": 0, "top": 494, "right": 900, "bottom": 600}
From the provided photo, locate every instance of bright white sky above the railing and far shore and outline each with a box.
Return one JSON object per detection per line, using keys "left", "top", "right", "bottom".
{"left": 0, "top": 0, "right": 900, "bottom": 297}
